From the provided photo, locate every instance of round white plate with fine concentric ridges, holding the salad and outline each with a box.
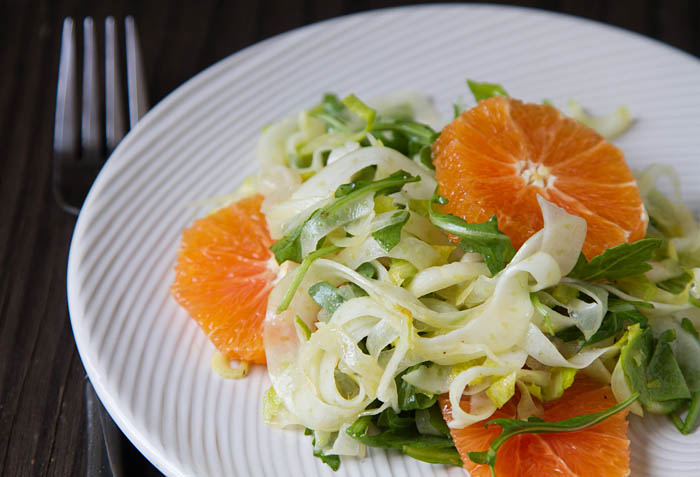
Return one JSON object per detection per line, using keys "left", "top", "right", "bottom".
{"left": 68, "top": 5, "right": 700, "bottom": 477}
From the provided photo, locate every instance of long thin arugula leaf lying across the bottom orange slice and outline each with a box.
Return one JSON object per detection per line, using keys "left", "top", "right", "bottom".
{"left": 468, "top": 393, "right": 639, "bottom": 477}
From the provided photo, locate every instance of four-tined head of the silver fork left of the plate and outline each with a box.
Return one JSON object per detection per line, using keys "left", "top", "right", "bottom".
{"left": 52, "top": 16, "right": 148, "bottom": 215}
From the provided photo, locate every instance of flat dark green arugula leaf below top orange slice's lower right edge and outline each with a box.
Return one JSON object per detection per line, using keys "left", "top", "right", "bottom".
{"left": 568, "top": 238, "right": 662, "bottom": 281}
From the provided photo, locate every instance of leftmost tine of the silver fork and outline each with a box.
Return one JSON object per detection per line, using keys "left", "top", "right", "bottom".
{"left": 53, "top": 18, "right": 78, "bottom": 156}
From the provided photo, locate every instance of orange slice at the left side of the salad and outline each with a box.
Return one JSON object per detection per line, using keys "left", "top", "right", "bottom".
{"left": 170, "top": 195, "right": 277, "bottom": 364}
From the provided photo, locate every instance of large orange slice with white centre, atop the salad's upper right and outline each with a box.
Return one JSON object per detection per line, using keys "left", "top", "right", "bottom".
{"left": 433, "top": 97, "right": 648, "bottom": 259}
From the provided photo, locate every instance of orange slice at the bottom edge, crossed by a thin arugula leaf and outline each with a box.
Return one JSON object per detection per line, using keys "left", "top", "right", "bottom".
{"left": 440, "top": 376, "right": 629, "bottom": 477}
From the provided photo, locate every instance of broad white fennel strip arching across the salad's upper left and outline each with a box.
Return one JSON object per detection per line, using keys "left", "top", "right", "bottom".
{"left": 263, "top": 146, "right": 437, "bottom": 239}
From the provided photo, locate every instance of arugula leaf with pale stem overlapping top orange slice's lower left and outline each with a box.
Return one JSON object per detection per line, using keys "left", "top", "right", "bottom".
{"left": 428, "top": 193, "right": 515, "bottom": 275}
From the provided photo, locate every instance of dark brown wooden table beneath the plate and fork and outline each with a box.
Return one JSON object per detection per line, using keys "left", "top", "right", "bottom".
{"left": 0, "top": 0, "right": 700, "bottom": 476}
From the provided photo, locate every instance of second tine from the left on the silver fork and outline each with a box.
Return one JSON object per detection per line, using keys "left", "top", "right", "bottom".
{"left": 82, "top": 17, "right": 101, "bottom": 160}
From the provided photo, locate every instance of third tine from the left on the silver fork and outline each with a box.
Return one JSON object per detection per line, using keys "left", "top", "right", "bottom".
{"left": 105, "top": 17, "right": 125, "bottom": 154}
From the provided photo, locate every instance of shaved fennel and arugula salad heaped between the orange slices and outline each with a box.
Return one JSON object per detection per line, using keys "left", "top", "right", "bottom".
{"left": 174, "top": 81, "right": 700, "bottom": 475}
